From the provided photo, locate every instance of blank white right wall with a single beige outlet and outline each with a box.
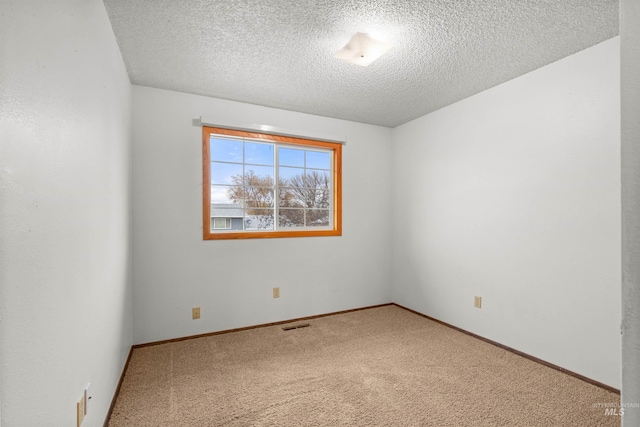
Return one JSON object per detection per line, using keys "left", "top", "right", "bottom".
{"left": 392, "top": 38, "right": 621, "bottom": 387}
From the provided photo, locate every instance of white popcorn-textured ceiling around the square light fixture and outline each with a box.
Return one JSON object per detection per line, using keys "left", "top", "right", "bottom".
{"left": 105, "top": 0, "right": 618, "bottom": 127}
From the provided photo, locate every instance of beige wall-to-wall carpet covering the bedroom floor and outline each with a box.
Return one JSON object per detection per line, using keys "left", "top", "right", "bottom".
{"left": 109, "top": 306, "right": 620, "bottom": 427}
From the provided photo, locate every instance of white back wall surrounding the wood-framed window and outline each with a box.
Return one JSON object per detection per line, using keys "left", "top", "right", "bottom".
{"left": 133, "top": 86, "right": 391, "bottom": 343}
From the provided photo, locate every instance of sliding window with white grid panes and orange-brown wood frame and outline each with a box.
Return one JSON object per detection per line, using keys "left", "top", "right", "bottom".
{"left": 202, "top": 126, "right": 342, "bottom": 240}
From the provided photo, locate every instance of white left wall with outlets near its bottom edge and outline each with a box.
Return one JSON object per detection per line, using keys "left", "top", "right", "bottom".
{"left": 0, "top": 0, "right": 132, "bottom": 427}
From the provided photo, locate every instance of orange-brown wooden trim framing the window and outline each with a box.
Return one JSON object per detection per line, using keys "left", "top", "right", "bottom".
{"left": 202, "top": 126, "right": 342, "bottom": 240}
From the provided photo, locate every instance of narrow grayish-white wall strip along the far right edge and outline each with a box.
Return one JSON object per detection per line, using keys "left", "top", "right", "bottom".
{"left": 620, "top": 0, "right": 640, "bottom": 427}
